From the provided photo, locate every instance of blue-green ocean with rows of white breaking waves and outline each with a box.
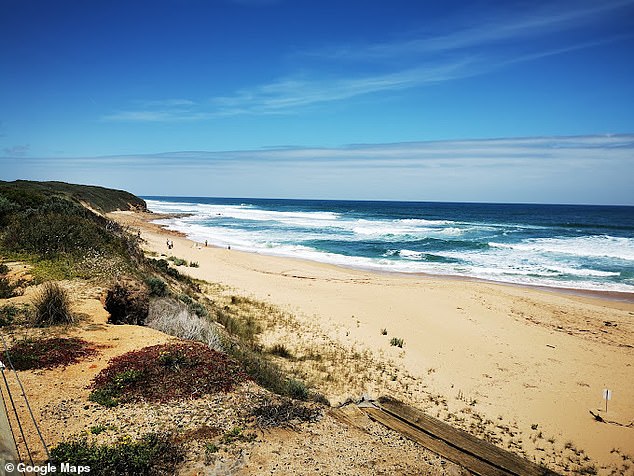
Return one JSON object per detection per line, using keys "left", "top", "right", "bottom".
{"left": 144, "top": 197, "right": 634, "bottom": 293}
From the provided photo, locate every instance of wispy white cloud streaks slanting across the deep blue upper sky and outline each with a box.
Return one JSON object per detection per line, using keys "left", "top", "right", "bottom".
{"left": 103, "top": 0, "right": 634, "bottom": 122}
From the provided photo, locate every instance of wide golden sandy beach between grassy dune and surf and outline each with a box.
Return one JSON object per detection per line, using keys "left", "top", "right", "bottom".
{"left": 112, "top": 212, "right": 634, "bottom": 474}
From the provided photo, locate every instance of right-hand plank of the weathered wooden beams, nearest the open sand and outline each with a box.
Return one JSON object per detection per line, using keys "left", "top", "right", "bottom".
{"left": 377, "top": 397, "right": 557, "bottom": 476}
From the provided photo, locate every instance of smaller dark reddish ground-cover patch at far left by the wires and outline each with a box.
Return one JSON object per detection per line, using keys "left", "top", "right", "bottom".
{"left": 8, "top": 337, "right": 97, "bottom": 370}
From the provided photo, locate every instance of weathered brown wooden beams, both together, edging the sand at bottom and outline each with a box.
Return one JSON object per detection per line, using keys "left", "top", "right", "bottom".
{"left": 359, "top": 397, "right": 557, "bottom": 476}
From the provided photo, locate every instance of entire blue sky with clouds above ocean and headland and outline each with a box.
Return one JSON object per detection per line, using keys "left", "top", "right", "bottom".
{"left": 0, "top": 0, "right": 634, "bottom": 205}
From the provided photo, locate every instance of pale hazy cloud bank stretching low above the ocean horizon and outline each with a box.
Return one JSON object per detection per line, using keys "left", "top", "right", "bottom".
{"left": 0, "top": 134, "right": 634, "bottom": 205}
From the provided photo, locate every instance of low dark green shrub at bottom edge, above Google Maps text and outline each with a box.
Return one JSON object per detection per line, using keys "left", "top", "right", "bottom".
{"left": 51, "top": 433, "right": 185, "bottom": 476}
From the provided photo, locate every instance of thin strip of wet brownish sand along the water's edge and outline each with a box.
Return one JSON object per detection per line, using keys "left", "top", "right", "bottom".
{"left": 144, "top": 211, "right": 634, "bottom": 303}
